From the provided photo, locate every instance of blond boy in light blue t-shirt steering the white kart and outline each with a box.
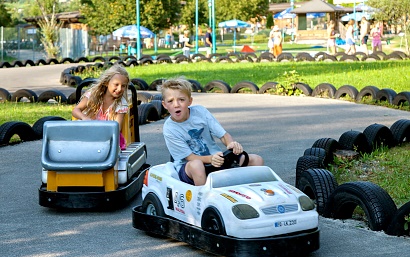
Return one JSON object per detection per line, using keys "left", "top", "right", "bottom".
{"left": 161, "top": 78, "right": 263, "bottom": 186}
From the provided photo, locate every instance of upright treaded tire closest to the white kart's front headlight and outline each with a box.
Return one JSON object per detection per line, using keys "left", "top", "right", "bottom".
{"left": 296, "top": 169, "right": 337, "bottom": 215}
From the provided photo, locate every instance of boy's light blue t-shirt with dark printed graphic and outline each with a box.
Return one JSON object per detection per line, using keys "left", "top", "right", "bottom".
{"left": 163, "top": 105, "right": 226, "bottom": 170}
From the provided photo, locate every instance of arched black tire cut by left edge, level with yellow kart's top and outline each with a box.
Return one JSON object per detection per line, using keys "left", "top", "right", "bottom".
{"left": 0, "top": 121, "right": 37, "bottom": 145}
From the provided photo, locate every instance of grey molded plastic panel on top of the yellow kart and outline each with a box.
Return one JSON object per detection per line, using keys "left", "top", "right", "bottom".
{"left": 41, "top": 120, "right": 119, "bottom": 171}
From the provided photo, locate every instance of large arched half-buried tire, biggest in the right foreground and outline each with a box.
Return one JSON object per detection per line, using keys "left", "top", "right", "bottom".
{"left": 323, "top": 181, "right": 397, "bottom": 231}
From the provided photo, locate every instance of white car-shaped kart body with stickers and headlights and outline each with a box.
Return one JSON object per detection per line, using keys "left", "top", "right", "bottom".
{"left": 142, "top": 162, "right": 319, "bottom": 238}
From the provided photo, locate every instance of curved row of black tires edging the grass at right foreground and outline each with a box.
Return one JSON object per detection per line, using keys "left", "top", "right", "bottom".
{"left": 296, "top": 119, "right": 410, "bottom": 236}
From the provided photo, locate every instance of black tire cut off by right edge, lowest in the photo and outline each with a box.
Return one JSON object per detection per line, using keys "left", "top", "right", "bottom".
{"left": 386, "top": 202, "right": 410, "bottom": 236}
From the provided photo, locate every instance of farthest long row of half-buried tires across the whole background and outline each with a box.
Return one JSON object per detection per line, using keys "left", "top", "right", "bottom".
{"left": 0, "top": 48, "right": 409, "bottom": 68}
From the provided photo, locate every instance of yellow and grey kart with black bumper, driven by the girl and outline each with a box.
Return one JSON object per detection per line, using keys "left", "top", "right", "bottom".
{"left": 39, "top": 85, "right": 150, "bottom": 209}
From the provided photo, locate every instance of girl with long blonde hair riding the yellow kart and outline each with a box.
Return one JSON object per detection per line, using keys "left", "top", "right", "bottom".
{"left": 72, "top": 64, "right": 130, "bottom": 150}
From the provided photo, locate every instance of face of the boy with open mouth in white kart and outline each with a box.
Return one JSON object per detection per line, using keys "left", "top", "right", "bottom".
{"left": 162, "top": 89, "right": 192, "bottom": 122}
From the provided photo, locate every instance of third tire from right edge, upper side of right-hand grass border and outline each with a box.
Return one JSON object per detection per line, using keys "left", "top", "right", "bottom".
{"left": 339, "top": 130, "right": 371, "bottom": 154}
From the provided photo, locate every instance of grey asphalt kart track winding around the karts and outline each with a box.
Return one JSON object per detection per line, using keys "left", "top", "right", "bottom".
{"left": 0, "top": 64, "right": 410, "bottom": 254}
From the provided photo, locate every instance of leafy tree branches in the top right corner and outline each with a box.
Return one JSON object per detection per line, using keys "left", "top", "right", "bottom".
{"left": 367, "top": 0, "right": 410, "bottom": 54}
